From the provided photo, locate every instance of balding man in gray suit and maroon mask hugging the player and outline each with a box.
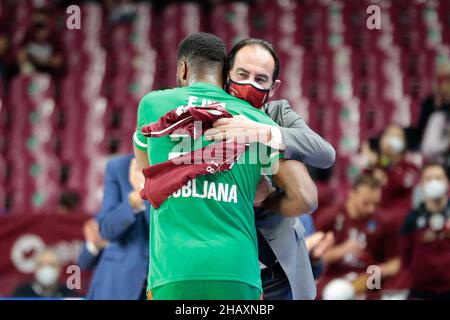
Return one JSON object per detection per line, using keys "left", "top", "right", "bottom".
{"left": 209, "top": 39, "right": 335, "bottom": 300}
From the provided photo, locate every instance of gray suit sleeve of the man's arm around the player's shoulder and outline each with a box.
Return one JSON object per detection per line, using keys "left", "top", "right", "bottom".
{"left": 269, "top": 100, "right": 336, "bottom": 169}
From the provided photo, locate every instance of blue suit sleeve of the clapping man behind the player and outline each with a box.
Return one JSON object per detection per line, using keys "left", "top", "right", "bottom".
{"left": 98, "top": 161, "right": 136, "bottom": 241}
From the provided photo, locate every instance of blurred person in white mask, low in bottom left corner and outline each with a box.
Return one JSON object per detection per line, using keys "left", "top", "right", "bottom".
{"left": 14, "top": 249, "right": 77, "bottom": 298}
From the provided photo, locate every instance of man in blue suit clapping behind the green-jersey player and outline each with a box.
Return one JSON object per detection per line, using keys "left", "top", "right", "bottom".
{"left": 80, "top": 154, "right": 149, "bottom": 300}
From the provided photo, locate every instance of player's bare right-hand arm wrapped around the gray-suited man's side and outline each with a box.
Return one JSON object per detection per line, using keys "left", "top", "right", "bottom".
{"left": 262, "top": 159, "right": 318, "bottom": 217}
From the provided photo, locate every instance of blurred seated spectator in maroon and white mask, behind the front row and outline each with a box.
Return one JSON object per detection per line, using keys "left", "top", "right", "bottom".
{"left": 366, "top": 124, "right": 419, "bottom": 229}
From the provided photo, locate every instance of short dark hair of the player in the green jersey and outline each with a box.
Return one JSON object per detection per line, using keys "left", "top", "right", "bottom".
{"left": 178, "top": 32, "right": 227, "bottom": 74}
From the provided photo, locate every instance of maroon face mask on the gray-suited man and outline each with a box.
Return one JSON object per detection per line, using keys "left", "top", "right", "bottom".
{"left": 226, "top": 78, "right": 270, "bottom": 109}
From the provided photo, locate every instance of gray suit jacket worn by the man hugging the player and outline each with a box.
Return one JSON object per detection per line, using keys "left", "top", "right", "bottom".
{"left": 255, "top": 100, "right": 336, "bottom": 300}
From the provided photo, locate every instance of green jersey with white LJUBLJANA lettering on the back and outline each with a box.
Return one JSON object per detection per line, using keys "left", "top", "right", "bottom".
{"left": 133, "top": 82, "right": 279, "bottom": 290}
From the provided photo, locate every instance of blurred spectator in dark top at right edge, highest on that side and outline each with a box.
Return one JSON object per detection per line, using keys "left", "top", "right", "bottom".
{"left": 409, "top": 62, "right": 450, "bottom": 150}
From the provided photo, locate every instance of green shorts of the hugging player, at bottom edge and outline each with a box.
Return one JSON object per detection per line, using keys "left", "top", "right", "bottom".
{"left": 147, "top": 280, "right": 262, "bottom": 300}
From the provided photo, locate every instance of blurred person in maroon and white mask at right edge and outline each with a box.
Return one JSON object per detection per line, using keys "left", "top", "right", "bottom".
{"left": 400, "top": 164, "right": 450, "bottom": 299}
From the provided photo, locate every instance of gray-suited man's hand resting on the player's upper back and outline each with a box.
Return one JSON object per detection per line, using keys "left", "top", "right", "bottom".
{"left": 205, "top": 115, "right": 272, "bottom": 144}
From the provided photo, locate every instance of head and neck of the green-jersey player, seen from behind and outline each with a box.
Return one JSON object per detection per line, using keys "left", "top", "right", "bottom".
{"left": 177, "top": 32, "right": 226, "bottom": 86}
